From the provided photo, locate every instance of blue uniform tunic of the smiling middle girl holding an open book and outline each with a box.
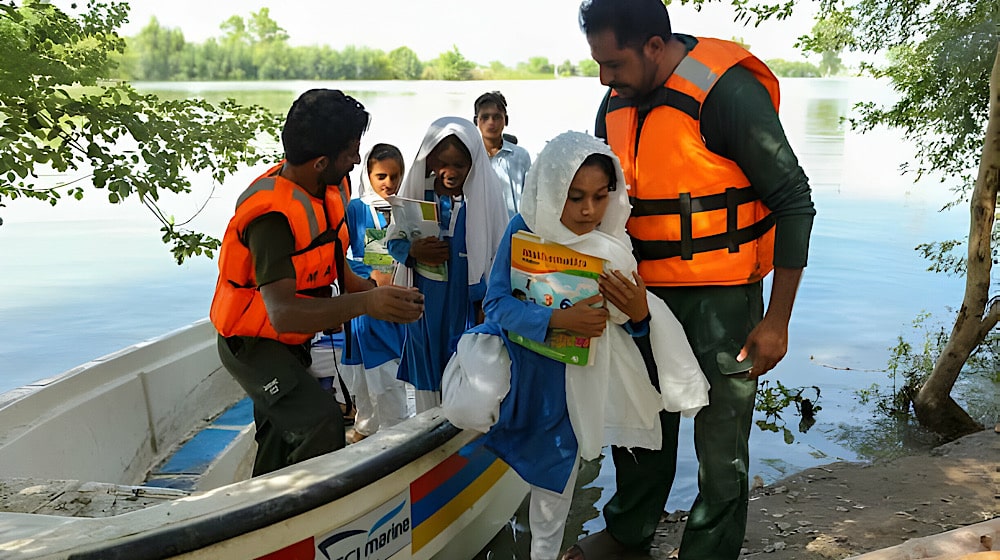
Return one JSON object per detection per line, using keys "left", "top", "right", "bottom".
{"left": 388, "top": 195, "right": 486, "bottom": 391}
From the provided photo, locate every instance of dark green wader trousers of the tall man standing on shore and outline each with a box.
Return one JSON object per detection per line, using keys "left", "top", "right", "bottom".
{"left": 604, "top": 282, "right": 764, "bottom": 560}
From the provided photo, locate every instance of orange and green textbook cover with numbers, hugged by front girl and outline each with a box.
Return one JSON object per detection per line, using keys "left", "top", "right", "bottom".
{"left": 507, "top": 231, "right": 604, "bottom": 366}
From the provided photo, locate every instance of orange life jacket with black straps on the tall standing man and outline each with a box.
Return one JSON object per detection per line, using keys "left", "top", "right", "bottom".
{"left": 605, "top": 38, "right": 779, "bottom": 286}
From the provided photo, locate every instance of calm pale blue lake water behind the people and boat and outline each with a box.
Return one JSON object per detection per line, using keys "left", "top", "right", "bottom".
{"left": 0, "top": 78, "right": 968, "bottom": 552}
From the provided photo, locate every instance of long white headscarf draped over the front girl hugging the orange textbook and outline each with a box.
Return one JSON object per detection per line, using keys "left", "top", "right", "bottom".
{"left": 521, "top": 132, "right": 708, "bottom": 459}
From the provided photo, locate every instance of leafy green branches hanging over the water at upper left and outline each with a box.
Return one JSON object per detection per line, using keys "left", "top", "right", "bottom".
{"left": 0, "top": 0, "right": 280, "bottom": 262}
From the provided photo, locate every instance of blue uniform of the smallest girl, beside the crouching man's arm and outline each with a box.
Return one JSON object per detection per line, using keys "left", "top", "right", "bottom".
{"left": 341, "top": 198, "right": 405, "bottom": 369}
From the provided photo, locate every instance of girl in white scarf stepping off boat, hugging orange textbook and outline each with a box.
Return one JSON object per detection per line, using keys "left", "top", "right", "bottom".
{"left": 444, "top": 132, "right": 708, "bottom": 560}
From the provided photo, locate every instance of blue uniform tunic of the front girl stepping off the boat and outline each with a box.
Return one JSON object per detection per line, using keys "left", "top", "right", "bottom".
{"left": 470, "top": 214, "right": 579, "bottom": 492}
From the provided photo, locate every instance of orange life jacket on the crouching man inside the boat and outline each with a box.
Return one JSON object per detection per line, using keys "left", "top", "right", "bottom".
{"left": 209, "top": 164, "right": 350, "bottom": 344}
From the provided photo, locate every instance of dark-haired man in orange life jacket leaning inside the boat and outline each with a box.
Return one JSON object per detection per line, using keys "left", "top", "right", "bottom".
{"left": 210, "top": 89, "right": 423, "bottom": 476}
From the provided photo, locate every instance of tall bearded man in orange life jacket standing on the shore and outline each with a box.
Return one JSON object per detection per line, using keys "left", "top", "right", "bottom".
{"left": 565, "top": 0, "right": 815, "bottom": 560}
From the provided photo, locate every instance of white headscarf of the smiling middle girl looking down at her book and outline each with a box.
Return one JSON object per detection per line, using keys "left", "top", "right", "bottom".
{"left": 386, "top": 117, "right": 508, "bottom": 285}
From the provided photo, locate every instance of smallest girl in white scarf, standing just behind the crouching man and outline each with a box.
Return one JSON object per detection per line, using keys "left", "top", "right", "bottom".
{"left": 342, "top": 144, "right": 407, "bottom": 441}
